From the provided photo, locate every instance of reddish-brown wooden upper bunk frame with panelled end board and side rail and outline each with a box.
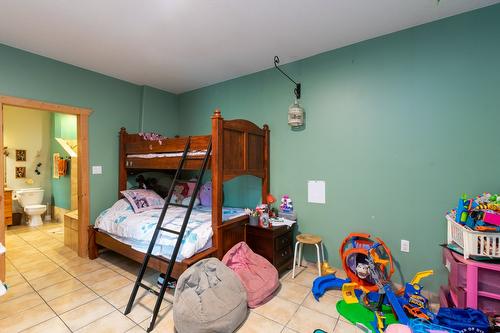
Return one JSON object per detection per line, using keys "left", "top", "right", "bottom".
{"left": 119, "top": 110, "right": 269, "bottom": 198}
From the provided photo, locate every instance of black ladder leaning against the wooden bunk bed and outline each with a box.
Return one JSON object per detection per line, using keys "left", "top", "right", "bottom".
{"left": 125, "top": 137, "right": 212, "bottom": 332}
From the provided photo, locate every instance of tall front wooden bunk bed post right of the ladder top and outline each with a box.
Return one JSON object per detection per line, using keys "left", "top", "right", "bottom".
{"left": 211, "top": 109, "right": 224, "bottom": 258}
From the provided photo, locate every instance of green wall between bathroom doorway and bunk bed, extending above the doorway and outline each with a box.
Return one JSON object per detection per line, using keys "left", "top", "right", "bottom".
{"left": 0, "top": 44, "right": 177, "bottom": 223}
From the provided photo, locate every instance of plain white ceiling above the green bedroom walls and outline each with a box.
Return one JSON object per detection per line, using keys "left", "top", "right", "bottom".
{"left": 0, "top": 0, "right": 500, "bottom": 93}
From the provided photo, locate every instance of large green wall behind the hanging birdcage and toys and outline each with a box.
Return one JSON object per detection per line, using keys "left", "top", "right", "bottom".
{"left": 179, "top": 5, "right": 500, "bottom": 291}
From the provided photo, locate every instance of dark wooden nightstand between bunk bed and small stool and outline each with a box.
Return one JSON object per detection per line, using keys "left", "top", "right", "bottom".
{"left": 245, "top": 224, "right": 295, "bottom": 273}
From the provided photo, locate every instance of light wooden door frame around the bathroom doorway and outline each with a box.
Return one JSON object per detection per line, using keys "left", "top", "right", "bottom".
{"left": 0, "top": 95, "right": 92, "bottom": 281}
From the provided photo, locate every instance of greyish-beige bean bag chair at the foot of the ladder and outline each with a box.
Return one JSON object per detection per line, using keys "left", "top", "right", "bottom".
{"left": 173, "top": 258, "right": 248, "bottom": 333}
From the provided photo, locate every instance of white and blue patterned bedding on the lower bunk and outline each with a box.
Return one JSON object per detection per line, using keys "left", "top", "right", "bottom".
{"left": 95, "top": 199, "right": 245, "bottom": 261}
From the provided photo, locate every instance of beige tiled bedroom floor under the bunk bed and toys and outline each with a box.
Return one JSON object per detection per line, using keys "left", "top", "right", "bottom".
{"left": 0, "top": 223, "right": 360, "bottom": 333}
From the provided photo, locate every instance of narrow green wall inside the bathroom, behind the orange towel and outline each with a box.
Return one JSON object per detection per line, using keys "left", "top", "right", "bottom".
{"left": 48, "top": 113, "right": 77, "bottom": 210}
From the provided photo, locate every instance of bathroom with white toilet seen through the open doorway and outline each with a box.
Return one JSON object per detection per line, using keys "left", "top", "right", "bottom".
{"left": 3, "top": 105, "right": 78, "bottom": 250}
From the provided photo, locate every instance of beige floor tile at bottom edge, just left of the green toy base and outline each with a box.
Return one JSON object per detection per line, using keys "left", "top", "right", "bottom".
{"left": 286, "top": 306, "right": 337, "bottom": 333}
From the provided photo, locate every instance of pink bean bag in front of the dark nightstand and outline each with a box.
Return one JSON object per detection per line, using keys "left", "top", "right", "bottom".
{"left": 222, "top": 242, "right": 280, "bottom": 308}
